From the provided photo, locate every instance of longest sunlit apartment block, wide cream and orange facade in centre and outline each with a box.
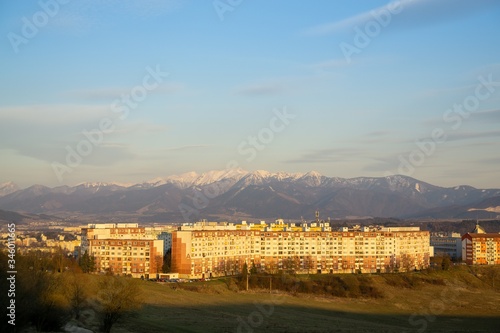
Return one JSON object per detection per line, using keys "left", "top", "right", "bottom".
{"left": 172, "top": 220, "right": 430, "bottom": 278}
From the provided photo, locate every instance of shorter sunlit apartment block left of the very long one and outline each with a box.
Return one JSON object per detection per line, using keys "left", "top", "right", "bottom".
{"left": 81, "top": 223, "right": 171, "bottom": 278}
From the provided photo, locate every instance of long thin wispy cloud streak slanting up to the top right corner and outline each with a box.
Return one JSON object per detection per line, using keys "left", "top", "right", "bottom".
{"left": 304, "top": 0, "right": 500, "bottom": 35}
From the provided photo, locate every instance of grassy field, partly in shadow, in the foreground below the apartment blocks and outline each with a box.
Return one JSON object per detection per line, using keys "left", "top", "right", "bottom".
{"left": 113, "top": 266, "right": 500, "bottom": 333}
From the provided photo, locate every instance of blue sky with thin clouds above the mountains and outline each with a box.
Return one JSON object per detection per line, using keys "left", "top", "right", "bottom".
{"left": 0, "top": 0, "right": 500, "bottom": 188}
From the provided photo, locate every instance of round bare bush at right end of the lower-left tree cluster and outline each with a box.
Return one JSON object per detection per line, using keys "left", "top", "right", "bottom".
{"left": 98, "top": 276, "right": 142, "bottom": 333}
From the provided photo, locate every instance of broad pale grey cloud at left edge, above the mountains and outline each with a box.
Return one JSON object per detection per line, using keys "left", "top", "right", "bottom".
{"left": 0, "top": 105, "right": 167, "bottom": 165}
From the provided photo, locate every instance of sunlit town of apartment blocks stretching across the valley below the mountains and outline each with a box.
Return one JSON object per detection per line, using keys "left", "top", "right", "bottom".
{"left": 2, "top": 219, "right": 500, "bottom": 280}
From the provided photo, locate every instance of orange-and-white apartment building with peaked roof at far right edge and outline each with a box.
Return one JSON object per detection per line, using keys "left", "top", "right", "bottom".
{"left": 462, "top": 225, "right": 500, "bottom": 265}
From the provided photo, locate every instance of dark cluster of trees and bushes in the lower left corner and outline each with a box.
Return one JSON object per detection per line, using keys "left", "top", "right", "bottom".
{"left": 0, "top": 250, "right": 141, "bottom": 332}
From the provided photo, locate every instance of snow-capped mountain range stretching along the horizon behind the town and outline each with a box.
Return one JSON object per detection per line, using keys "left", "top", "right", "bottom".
{"left": 0, "top": 169, "right": 500, "bottom": 222}
